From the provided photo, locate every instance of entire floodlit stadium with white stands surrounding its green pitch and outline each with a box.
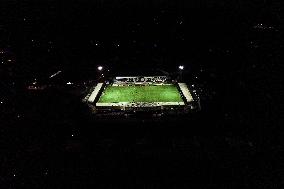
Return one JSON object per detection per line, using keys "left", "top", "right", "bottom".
{"left": 84, "top": 76, "right": 199, "bottom": 114}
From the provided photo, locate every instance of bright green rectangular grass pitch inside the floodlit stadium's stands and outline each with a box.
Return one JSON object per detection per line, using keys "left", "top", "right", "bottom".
{"left": 98, "top": 85, "right": 183, "bottom": 103}
